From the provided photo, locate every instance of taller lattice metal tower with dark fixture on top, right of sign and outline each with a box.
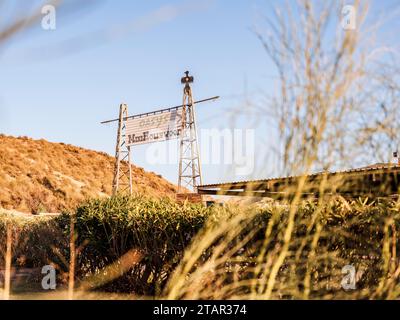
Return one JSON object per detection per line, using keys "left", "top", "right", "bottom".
{"left": 178, "top": 71, "right": 202, "bottom": 193}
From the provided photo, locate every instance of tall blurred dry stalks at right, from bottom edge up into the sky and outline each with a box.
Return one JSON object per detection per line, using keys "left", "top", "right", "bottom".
{"left": 158, "top": 0, "right": 392, "bottom": 299}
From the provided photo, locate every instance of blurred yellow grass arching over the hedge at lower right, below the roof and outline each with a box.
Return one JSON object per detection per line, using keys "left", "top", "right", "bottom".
{"left": 164, "top": 199, "right": 400, "bottom": 299}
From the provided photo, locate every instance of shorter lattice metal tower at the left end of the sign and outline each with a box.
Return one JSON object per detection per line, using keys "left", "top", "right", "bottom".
{"left": 113, "top": 104, "right": 132, "bottom": 195}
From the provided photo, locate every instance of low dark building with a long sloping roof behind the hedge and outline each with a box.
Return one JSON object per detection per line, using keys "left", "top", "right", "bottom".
{"left": 198, "top": 164, "right": 400, "bottom": 200}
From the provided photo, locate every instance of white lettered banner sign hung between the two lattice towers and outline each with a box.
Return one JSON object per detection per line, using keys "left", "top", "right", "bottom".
{"left": 125, "top": 108, "right": 183, "bottom": 146}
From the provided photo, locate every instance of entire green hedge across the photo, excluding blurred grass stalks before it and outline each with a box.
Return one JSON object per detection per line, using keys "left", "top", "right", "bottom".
{"left": 0, "top": 196, "right": 400, "bottom": 297}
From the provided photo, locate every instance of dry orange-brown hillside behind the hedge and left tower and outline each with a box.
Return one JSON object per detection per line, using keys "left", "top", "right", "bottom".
{"left": 0, "top": 135, "right": 177, "bottom": 214}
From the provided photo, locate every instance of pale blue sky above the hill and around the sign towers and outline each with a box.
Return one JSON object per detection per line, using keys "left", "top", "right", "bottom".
{"left": 0, "top": 0, "right": 399, "bottom": 183}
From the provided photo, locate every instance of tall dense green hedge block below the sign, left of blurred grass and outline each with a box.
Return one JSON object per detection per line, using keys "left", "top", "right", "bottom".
{"left": 60, "top": 196, "right": 210, "bottom": 295}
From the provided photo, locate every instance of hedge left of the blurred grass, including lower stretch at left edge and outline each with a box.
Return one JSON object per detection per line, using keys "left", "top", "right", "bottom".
{"left": 0, "top": 196, "right": 210, "bottom": 295}
